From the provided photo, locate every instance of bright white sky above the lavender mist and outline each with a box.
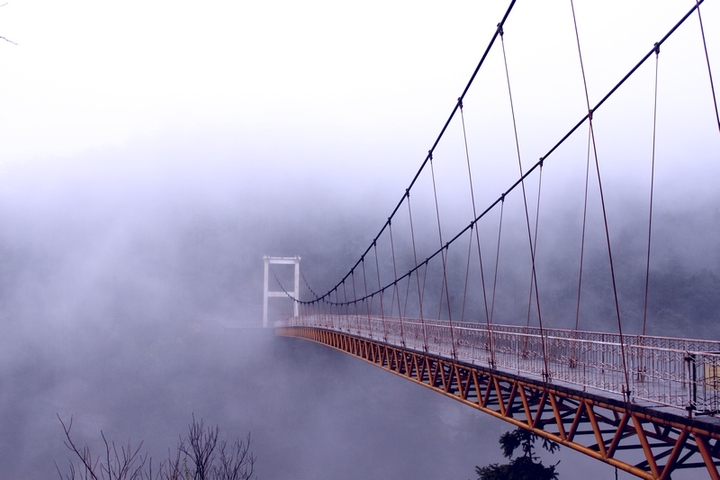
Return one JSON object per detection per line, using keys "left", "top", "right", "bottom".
{"left": 0, "top": 0, "right": 720, "bottom": 196}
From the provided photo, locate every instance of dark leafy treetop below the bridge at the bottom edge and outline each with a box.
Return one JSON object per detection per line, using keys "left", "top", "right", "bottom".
{"left": 475, "top": 428, "right": 560, "bottom": 480}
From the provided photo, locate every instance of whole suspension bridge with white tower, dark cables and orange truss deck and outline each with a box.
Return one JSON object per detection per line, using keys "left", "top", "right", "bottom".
{"left": 264, "top": 0, "right": 720, "bottom": 479}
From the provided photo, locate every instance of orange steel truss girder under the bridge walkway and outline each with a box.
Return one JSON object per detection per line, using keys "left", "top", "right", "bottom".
{"left": 276, "top": 327, "right": 720, "bottom": 480}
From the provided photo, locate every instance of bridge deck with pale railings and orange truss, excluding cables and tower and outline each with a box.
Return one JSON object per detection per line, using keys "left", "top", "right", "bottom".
{"left": 276, "top": 315, "right": 720, "bottom": 480}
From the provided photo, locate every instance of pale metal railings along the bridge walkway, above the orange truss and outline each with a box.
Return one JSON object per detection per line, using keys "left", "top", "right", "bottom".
{"left": 277, "top": 314, "right": 720, "bottom": 415}
